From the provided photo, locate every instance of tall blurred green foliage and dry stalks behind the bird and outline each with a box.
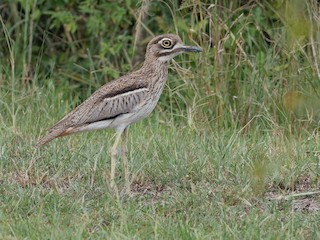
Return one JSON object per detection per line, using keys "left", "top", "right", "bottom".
{"left": 0, "top": 0, "right": 320, "bottom": 132}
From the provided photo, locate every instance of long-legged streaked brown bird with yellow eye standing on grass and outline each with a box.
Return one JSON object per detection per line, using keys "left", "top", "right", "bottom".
{"left": 36, "top": 34, "right": 202, "bottom": 192}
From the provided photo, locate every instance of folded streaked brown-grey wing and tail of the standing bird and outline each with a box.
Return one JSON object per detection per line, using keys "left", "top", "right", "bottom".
{"left": 36, "top": 78, "right": 149, "bottom": 147}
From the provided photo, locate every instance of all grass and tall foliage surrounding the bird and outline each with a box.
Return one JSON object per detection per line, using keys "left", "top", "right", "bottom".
{"left": 0, "top": 0, "right": 320, "bottom": 239}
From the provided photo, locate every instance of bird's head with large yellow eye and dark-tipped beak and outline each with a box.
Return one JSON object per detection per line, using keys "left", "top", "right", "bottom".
{"left": 146, "top": 34, "right": 202, "bottom": 62}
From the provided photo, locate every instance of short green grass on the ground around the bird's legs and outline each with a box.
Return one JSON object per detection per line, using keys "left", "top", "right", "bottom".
{"left": 0, "top": 85, "right": 320, "bottom": 239}
